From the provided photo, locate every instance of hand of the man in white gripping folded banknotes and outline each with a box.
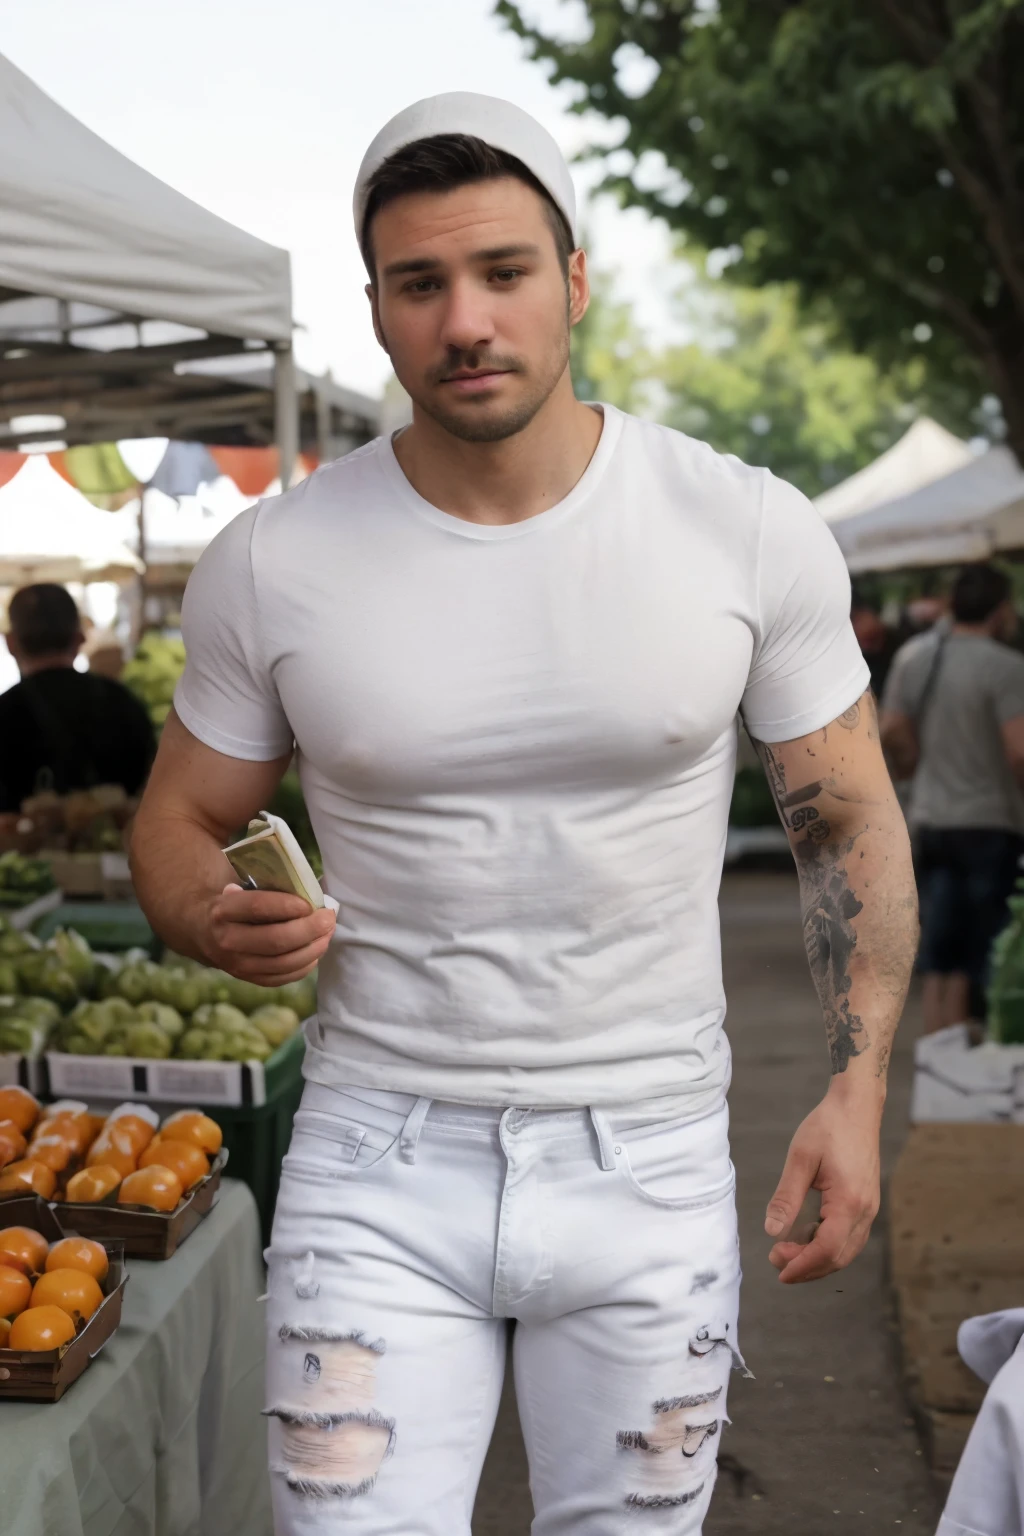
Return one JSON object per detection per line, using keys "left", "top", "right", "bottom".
{"left": 203, "top": 885, "right": 336, "bottom": 986}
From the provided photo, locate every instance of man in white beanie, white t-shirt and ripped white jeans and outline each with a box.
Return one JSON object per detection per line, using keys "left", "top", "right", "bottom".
{"left": 134, "top": 94, "right": 915, "bottom": 1536}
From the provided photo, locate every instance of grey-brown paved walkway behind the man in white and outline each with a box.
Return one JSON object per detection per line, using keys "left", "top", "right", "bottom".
{"left": 473, "top": 874, "right": 938, "bottom": 1536}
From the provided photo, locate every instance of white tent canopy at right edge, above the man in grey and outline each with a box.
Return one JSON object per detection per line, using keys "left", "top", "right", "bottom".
{"left": 832, "top": 447, "right": 1024, "bottom": 573}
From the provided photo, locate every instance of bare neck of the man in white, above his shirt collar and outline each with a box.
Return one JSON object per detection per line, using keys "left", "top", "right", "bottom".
{"left": 395, "top": 376, "right": 602, "bottom": 527}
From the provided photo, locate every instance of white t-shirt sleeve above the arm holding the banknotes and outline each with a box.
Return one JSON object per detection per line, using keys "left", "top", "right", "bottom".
{"left": 173, "top": 505, "right": 292, "bottom": 762}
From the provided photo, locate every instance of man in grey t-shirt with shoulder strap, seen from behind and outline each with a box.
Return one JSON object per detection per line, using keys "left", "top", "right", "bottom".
{"left": 881, "top": 565, "right": 1024, "bottom": 1031}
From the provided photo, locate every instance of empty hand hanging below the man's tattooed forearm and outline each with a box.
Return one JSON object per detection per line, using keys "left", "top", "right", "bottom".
{"left": 765, "top": 1074, "right": 881, "bottom": 1286}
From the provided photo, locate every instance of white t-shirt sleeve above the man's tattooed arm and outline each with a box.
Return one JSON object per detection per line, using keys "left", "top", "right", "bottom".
{"left": 742, "top": 473, "right": 870, "bottom": 742}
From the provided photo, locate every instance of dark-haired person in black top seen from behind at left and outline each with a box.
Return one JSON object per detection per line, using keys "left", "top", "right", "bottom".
{"left": 0, "top": 582, "right": 155, "bottom": 811}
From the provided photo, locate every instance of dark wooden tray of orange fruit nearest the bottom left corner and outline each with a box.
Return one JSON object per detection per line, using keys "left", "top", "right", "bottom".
{"left": 0, "top": 1195, "right": 127, "bottom": 1402}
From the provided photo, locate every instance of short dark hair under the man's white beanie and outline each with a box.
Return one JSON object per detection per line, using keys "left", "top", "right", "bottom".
{"left": 359, "top": 134, "right": 576, "bottom": 283}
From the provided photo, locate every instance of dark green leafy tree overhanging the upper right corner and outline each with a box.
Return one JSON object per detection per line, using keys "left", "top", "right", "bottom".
{"left": 496, "top": 0, "right": 1024, "bottom": 458}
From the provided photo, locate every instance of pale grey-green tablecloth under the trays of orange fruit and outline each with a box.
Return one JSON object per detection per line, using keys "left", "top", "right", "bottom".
{"left": 0, "top": 1180, "right": 272, "bottom": 1536}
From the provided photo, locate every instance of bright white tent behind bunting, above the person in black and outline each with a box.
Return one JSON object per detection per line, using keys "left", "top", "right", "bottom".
{"left": 0, "top": 453, "right": 143, "bottom": 587}
